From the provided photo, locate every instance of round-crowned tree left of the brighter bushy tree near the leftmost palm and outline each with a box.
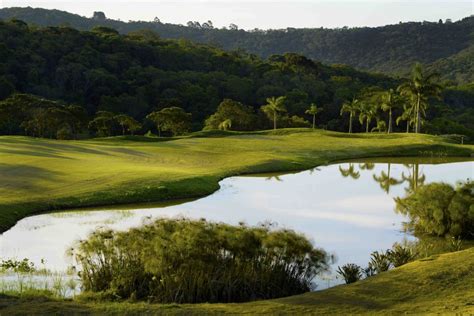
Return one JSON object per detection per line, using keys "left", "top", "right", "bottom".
{"left": 147, "top": 106, "right": 191, "bottom": 136}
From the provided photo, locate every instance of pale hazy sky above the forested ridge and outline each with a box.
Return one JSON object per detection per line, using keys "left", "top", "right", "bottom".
{"left": 0, "top": 0, "right": 474, "bottom": 29}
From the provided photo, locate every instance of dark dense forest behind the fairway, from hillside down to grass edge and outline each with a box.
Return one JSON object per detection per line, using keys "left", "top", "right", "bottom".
{"left": 0, "top": 20, "right": 474, "bottom": 138}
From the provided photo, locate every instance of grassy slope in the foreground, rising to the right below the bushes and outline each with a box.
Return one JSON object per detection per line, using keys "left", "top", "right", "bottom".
{"left": 0, "top": 248, "right": 474, "bottom": 315}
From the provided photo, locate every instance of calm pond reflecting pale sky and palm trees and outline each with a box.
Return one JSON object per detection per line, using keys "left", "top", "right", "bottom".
{"left": 0, "top": 158, "right": 474, "bottom": 288}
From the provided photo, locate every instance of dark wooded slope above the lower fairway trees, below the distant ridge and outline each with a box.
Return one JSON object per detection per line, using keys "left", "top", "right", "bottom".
{"left": 0, "top": 21, "right": 394, "bottom": 128}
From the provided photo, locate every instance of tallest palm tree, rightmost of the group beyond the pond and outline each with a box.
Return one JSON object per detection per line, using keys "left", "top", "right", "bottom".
{"left": 398, "top": 63, "right": 441, "bottom": 133}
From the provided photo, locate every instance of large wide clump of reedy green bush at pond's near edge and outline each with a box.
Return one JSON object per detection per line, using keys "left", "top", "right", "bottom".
{"left": 73, "top": 219, "right": 328, "bottom": 303}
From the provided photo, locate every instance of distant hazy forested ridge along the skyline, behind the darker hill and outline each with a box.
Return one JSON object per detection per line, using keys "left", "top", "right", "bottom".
{"left": 0, "top": 8, "right": 474, "bottom": 83}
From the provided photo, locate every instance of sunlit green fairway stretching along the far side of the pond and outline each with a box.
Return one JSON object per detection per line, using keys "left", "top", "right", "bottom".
{"left": 0, "top": 129, "right": 474, "bottom": 232}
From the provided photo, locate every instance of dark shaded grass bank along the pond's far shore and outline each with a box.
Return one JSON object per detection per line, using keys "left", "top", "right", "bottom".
{"left": 0, "top": 132, "right": 474, "bottom": 234}
